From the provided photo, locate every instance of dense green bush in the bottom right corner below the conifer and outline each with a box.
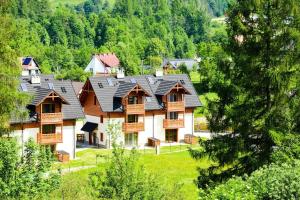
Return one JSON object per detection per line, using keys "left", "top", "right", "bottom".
{"left": 200, "top": 160, "right": 300, "bottom": 199}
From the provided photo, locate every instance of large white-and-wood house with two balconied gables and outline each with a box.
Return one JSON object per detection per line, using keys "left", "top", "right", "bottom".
{"left": 80, "top": 75, "right": 201, "bottom": 147}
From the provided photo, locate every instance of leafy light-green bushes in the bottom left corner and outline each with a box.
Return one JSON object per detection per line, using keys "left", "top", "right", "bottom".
{"left": 0, "top": 138, "right": 60, "bottom": 199}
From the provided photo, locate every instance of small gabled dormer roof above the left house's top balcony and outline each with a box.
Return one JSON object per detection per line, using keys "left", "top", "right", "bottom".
{"left": 31, "top": 88, "right": 69, "bottom": 106}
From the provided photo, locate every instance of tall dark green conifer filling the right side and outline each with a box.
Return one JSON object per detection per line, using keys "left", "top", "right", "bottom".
{"left": 191, "top": 0, "right": 300, "bottom": 188}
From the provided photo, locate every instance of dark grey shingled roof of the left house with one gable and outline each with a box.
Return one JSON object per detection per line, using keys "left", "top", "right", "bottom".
{"left": 11, "top": 75, "right": 84, "bottom": 123}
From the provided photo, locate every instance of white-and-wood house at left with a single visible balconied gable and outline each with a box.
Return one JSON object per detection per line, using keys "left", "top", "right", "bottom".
{"left": 10, "top": 75, "right": 84, "bottom": 159}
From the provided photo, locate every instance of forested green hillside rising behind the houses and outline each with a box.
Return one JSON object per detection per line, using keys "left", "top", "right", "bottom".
{"left": 3, "top": 0, "right": 227, "bottom": 80}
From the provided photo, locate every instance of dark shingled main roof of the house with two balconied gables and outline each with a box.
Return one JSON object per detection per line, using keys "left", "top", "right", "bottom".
{"left": 89, "top": 74, "right": 202, "bottom": 112}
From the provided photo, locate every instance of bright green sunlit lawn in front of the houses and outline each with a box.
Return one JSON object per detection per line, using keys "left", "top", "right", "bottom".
{"left": 50, "top": 145, "right": 211, "bottom": 200}
